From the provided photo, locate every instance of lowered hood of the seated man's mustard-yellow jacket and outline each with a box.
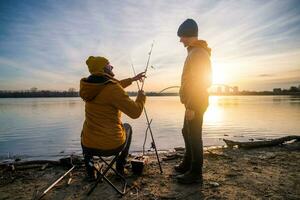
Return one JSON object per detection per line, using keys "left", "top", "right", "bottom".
{"left": 79, "top": 75, "right": 115, "bottom": 101}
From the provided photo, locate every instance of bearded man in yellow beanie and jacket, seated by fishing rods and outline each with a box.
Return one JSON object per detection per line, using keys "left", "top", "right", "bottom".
{"left": 80, "top": 56, "right": 146, "bottom": 184}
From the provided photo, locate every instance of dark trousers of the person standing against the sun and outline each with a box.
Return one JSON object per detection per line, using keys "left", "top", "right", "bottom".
{"left": 182, "top": 111, "right": 205, "bottom": 173}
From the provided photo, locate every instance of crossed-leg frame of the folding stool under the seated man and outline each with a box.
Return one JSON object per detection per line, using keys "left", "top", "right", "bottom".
{"left": 87, "top": 151, "right": 128, "bottom": 195}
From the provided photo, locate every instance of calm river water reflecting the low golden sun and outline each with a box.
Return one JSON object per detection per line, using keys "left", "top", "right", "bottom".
{"left": 0, "top": 96, "right": 300, "bottom": 160}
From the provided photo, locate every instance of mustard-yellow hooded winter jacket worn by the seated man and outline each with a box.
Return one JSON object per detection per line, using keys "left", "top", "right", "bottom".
{"left": 80, "top": 75, "right": 146, "bottom": 150}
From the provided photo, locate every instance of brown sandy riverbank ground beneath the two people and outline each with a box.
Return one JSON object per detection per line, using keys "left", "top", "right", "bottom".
{"left": 0, "top": 142, "right": 300, "bottom": 200}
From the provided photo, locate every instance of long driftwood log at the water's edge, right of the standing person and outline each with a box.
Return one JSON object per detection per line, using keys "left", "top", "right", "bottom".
{"left": 223, "top": 135, "right": 300, "bottom": 149}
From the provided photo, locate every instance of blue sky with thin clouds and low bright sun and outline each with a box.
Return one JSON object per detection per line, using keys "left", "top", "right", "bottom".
{"left": 0, "top": 0, "right": 300, "bottom": 91}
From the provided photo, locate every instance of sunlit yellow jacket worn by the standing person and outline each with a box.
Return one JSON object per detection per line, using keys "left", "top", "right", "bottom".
{"left": 179, "top": 40, "right": 212, "bottom": 111}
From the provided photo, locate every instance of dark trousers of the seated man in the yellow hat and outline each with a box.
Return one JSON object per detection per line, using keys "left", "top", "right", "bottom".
{"left": 81, "top": 123, "right": 132, "bottom": 176}
